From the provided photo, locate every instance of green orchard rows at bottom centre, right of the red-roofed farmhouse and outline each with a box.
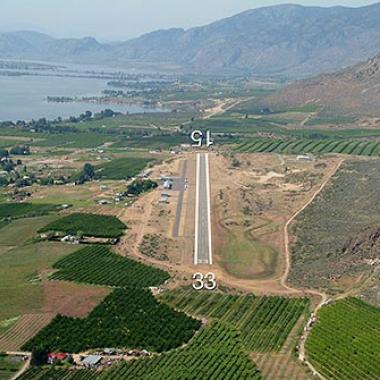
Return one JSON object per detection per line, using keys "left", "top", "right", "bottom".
{"left": 20, "top": 323, "right": 261, "bottom": 380}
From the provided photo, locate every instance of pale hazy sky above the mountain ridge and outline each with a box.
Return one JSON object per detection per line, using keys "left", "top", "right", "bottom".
{"left": 0, "top": 0, "right": 376, "bottom": 41}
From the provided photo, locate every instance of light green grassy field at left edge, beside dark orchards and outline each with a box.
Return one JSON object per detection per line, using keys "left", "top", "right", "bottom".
{"left": 0, "top": 216, "right": 77, "bottom": 326}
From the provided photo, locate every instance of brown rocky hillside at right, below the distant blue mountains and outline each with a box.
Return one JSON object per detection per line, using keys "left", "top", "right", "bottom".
{"left": 262, "top": 54, "right": 380, "bottom": 117}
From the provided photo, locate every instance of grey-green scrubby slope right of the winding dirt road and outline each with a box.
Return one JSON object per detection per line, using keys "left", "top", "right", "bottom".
{"left": 290, "top": 160, "right": 380, "bottom": 304}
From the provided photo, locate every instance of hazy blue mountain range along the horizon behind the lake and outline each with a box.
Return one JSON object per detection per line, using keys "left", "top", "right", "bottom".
{"left": 0, "top": 3, "right": 380, "bottom": 77}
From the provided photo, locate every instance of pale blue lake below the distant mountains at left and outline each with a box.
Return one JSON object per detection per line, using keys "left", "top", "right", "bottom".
{"left": 0, "top": 75, "right": 162, "bottom": 121}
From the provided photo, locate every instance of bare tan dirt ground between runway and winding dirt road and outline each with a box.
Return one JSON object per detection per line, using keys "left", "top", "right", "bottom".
{"left": 211, "top": 154, "right": 337, "bottom": 293}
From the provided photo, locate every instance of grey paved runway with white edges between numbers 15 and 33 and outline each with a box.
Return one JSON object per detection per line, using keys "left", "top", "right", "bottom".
{"left": 194, "top": 153, "right": 212, "bottom": 265}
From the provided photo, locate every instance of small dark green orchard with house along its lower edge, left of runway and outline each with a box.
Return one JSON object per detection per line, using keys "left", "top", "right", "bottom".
{"left": 39, "top": 213, "right": 126, "bottom": 238}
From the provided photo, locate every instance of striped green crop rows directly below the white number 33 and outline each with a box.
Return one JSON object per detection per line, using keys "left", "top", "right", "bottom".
{"left": 162, "top": 290, "right": 309, "bottom": 352}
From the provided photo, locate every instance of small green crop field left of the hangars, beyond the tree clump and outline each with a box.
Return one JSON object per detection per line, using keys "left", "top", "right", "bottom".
{"left": 96, "top": 157, "right": 152, "bottom": 180}
